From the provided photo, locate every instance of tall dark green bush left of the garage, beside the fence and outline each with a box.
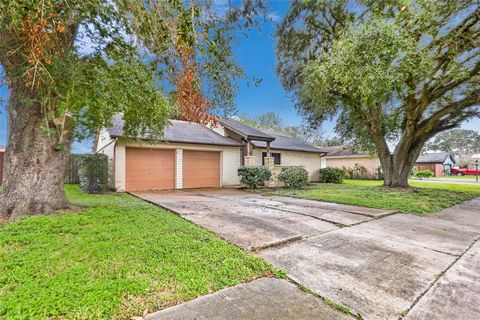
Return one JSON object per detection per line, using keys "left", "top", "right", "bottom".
{"left": 78, "top": 153, "right": 108, "bottom": 193}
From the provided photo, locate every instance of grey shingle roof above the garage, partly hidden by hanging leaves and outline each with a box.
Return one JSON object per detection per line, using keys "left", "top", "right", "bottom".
{"left": 108, "top": 115, "right": 243, "bottom": 147}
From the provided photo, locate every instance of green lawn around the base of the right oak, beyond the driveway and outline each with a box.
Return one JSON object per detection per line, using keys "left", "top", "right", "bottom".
{"left": 268, "top": 180, "right": 480, "bottom": 214}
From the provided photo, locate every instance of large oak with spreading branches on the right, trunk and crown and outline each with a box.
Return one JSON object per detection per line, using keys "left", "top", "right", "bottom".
{"left": 276, "top": 0, "right": 480, "bottom": 187}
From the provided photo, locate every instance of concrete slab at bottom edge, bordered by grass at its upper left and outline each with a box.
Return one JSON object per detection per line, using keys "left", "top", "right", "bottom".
{"left": 145, "top": 278, "right": 352, "bottom": 320}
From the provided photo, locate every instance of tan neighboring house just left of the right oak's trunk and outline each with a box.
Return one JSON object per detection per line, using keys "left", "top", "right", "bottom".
{"left": 318, "top": 146, "right": 380, "bottom": 178}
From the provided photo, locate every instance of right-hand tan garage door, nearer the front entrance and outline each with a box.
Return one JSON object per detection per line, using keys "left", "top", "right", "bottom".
{"left": 183, "top": 150, "right": 220, "bottom": 188}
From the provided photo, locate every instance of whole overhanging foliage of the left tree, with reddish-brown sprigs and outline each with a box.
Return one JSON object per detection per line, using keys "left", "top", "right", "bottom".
{"left": 0, "top": 0, "right": 262, "bottom": 147}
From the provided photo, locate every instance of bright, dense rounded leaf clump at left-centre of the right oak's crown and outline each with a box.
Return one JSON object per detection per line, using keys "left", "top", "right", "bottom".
{"left": 300, "top": 19, "right": 408, "bottom": 122}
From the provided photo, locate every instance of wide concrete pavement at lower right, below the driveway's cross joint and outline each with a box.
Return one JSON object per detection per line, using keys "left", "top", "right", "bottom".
{"left": 260, "top": 200, "right": 480, "bottom": 320}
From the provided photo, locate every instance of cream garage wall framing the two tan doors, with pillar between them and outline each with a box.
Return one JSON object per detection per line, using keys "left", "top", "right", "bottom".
{"left": 114, "top": 140, "right": 240, "bottom": 192}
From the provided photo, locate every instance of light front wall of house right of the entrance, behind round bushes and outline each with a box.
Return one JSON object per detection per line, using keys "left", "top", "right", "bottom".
{"left": 253, "top": 148, "right": 321, "bottom": 182}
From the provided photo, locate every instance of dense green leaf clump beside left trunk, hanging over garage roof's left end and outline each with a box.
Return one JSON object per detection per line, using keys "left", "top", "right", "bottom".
{"left": 43, "top": 55, "right": 170, "bottom": 140}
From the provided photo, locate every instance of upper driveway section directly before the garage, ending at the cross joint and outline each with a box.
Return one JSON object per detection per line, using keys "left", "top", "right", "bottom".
{"left": 133, "top": 189, "right": 391, "bottom": 250}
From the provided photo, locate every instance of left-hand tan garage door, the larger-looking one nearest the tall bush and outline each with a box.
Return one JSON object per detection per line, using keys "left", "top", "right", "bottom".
{"left": 125, "top": 148, "right": 175, "bottom": 191}
